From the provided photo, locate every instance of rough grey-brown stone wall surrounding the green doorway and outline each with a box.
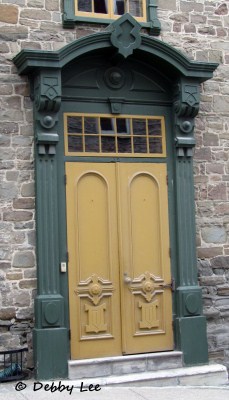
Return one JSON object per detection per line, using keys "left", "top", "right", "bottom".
{"left": 0, "top": 0, "right": 229, "bottom": 366}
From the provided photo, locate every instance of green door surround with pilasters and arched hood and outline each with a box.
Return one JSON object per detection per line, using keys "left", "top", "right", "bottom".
{"left": 14, "top": 14, "right": 217, "bottom": 379}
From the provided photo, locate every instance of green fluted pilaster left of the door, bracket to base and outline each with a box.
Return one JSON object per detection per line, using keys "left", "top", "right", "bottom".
{"left": 34, "top": 69, "right": 68, "bottom": 379}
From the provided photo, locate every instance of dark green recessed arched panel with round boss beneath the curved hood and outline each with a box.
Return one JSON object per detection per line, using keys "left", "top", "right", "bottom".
{"left": 62, "top": 52, "right": 171, "bottom": 101}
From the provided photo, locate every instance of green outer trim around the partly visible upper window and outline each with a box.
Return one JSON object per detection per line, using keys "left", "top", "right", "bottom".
{"left": 63, "top": 0, "right": 161, "bottom": 36}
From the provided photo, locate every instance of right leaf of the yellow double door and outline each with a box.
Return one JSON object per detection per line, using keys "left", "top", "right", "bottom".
{"left": 117, "top": 164, "right": 173, "bottom": 354}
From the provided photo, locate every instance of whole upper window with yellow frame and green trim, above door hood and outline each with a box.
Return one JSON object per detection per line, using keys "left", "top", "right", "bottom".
{"left": 63, "top": 0, "right": 160, "bottom": 36}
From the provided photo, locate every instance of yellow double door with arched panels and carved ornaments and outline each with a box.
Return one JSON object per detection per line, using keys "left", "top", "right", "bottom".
{"left": 66, "top": 162, "right": 173, "bottom": 359}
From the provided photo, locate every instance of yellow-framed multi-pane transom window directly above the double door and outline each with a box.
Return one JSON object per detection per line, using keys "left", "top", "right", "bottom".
{"left": 64, "top": 113, "right": 166, "bottom": 157}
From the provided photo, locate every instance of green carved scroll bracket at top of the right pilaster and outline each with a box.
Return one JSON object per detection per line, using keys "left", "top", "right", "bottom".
{"left": 174, "top": 78, "right": 200, "bottom": 157}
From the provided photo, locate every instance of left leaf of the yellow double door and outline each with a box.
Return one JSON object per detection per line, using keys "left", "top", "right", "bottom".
{"left": 66, "top": 163, "right": 121, "bottom": 359}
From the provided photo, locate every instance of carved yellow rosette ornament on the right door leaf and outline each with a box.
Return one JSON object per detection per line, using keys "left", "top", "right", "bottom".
{"left": 129, "top": 271, "right": 165, "bottom": 303}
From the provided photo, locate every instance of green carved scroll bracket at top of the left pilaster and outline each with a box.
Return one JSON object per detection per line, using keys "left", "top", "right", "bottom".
{"left": 34, "top": 69, "right": 61, "bottom": 155}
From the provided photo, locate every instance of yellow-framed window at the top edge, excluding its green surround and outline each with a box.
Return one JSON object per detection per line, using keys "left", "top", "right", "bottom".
{"left": 75, "top": 0, "right": 146, "bottom": 21}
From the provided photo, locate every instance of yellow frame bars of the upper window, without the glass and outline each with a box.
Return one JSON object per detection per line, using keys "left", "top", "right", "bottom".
{"left": 75, "top": 0, "right": 147, "bottom": 22}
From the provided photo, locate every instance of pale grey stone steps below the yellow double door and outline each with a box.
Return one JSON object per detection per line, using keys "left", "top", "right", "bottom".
{"left": 68, "top": 351, "right": 228, "bottom": 387}
